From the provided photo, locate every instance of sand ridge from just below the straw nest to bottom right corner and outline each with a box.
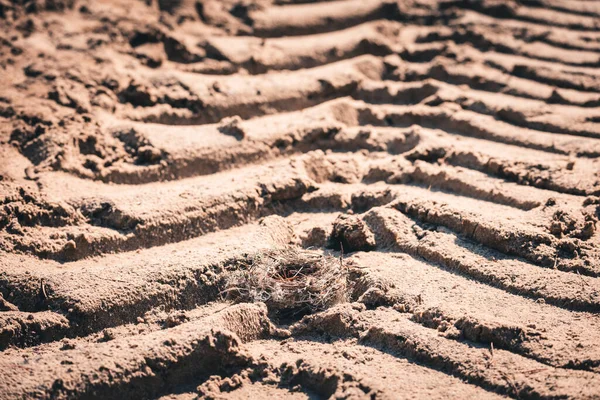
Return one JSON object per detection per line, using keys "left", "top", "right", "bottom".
{"left": 293, "top": 305, "right": 598, "bottom": 398}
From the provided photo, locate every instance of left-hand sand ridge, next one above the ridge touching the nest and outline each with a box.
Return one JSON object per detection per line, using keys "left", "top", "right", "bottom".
{"left": 3, "top": 161, "right": 314, "bottom": 261}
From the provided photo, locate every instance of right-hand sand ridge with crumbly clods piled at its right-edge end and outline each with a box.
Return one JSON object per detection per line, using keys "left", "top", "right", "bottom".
{"left": 296, "top": 178, "right": 599, "bottom": 277}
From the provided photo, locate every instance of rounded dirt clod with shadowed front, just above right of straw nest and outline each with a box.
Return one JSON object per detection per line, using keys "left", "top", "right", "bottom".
{"left": 329, "top": 214, "right": 375, "bottom": 252}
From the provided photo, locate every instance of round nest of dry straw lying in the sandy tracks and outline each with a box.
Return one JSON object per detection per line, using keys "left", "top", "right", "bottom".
{"left": 224, "top": 247, "right": 348, "bottom": 313}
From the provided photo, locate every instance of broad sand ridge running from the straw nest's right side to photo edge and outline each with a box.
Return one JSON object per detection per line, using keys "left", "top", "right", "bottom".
{"left": 348, "top": 250, "right": 600, "bottom": 372}
